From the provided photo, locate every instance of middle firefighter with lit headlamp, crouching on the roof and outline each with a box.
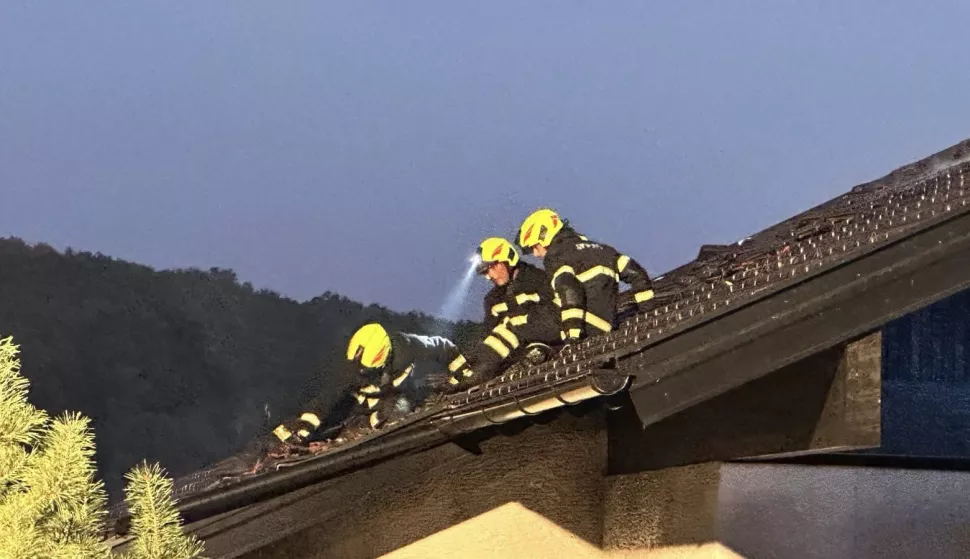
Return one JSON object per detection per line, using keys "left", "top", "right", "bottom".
{"left": 448, "top": 237, "right": 561, "bottom": 389}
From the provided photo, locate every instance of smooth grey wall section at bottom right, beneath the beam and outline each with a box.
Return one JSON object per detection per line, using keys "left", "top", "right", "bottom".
{"left": 717, "top": 464, "right": 970, "bottom": 559}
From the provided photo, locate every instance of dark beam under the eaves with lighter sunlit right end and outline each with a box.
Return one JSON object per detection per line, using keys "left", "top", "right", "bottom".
{"left": 608, "top": 332, "right": 882, "bottom": 474}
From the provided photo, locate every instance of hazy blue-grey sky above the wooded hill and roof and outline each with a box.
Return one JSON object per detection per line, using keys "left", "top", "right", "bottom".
{"left": 0, "top": 0, "right": 970, "bottom": 318}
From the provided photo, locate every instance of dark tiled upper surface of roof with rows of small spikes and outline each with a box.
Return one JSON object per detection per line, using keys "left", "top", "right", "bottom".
{"left": 104, "top": 136, "right": 970, "bottom": 540}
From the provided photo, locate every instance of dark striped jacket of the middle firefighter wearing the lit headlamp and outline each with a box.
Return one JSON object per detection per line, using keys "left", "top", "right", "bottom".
{"left": 448, "top": 261, "right": 561, "bottom": 385}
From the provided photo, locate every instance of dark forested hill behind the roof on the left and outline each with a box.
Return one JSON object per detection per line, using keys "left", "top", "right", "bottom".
{"left": 0, "top": 239, "right": 479, "bottom": 499}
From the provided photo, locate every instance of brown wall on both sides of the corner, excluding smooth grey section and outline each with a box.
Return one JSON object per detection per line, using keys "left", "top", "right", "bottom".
{"left": 229, "top": 410, "right": 737, "bottom": 559}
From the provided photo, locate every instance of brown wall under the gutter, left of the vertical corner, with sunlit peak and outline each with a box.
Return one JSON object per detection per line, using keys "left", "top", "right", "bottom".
{"left": 234, "top": 412, "right": 606, "bottom": 559}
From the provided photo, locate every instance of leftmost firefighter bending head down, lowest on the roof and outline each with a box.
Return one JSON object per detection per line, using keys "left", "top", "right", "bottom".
{"left": 347, "top": 323, "right": 459, "bottom": 429}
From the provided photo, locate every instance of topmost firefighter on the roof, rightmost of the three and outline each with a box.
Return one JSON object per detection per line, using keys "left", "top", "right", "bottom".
{"left": 519, "top": 208, "right": 654, "bottom": 342}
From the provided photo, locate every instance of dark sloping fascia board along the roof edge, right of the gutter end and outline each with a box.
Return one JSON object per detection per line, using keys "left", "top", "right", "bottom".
{"left": 617, "top": 208, "right": 970, "bottom": 425}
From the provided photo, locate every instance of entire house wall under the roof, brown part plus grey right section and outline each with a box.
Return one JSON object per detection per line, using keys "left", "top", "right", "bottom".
{"left": 194, "top": 404, "right": 970, "bottom": 559}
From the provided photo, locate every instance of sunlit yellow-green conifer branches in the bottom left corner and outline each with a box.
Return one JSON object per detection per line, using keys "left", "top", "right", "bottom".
{"left": 0, "top": 337, "right": 202, "bottom": 559}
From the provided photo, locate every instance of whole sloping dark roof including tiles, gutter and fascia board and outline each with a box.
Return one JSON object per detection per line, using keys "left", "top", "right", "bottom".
{"left": 106, "top": 136, "right": 970, "bottom": 544}
